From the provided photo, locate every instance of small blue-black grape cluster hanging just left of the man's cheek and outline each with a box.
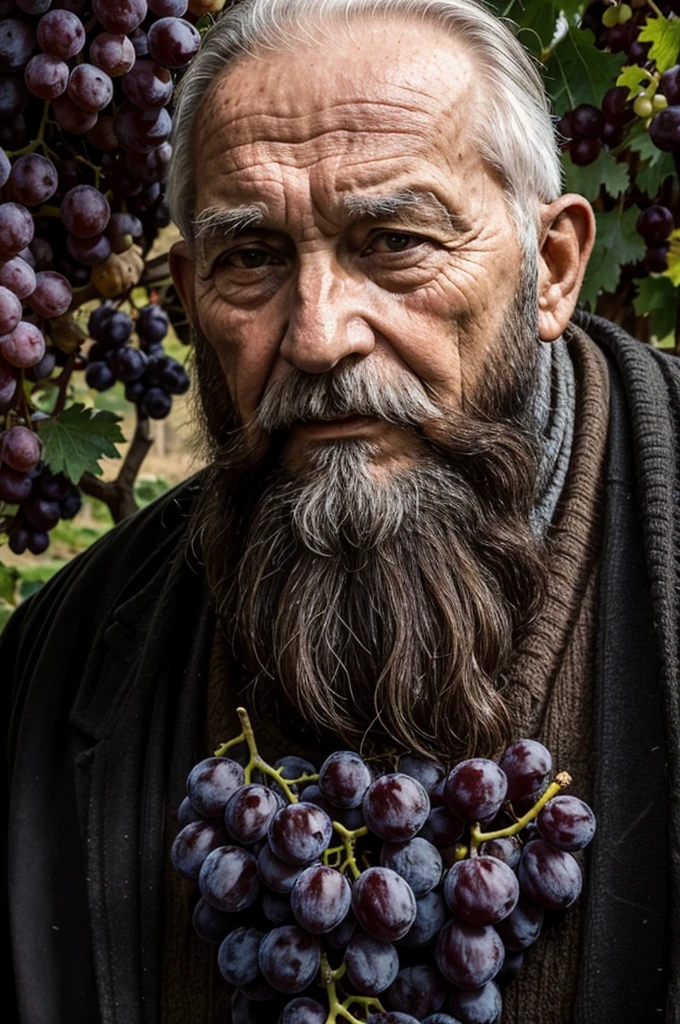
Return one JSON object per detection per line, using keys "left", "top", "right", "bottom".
{"left": 85, "top": 303, "right": 189, "bottom": 420}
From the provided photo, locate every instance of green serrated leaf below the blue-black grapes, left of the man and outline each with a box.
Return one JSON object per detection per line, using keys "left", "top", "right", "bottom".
{"left": 38, "top": 402, "right": 125, "bottom": 483}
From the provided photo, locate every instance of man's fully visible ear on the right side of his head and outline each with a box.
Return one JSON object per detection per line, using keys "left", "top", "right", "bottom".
{"left": 538, "top": 193, "right": 595, "bottom": 341}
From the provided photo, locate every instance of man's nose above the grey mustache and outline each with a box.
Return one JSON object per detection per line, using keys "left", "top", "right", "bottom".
{"left": 281, "top": 253, "right": 376, "bottom": 374}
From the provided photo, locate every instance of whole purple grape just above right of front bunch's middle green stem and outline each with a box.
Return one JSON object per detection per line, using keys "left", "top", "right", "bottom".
{"left": 362, "top": 772, "right": 430, "bottom": 843}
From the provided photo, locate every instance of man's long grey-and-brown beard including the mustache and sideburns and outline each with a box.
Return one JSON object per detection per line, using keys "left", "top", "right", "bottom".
{"left": 188, "top": 260, "right": 546, "bottom": 762}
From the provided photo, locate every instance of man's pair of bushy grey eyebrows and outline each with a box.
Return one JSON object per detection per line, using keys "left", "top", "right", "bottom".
{"left": 192, "top": 188, "right": 472, "bottom": 258}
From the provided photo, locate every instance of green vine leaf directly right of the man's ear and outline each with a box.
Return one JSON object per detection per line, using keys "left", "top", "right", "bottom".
{"left": 580, "top": 207, "right": 645, "bottom": 310}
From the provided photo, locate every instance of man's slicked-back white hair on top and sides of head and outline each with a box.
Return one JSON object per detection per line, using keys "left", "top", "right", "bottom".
{"left": 167, "top": 0, "right": 562, "bottom": 255}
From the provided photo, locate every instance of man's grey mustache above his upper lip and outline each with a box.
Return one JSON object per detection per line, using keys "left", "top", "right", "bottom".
{"left": 253, "top": 359, "right": 445, "bottom": 434}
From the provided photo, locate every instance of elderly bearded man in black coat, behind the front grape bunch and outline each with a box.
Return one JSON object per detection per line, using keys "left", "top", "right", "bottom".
{"left": 2, "top": 0, "right": 680, "bottom": 1024}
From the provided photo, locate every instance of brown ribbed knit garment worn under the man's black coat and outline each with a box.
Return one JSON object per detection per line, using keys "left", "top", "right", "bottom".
{"left": 161, "top": 325, "right": 608, "bottom": 1024}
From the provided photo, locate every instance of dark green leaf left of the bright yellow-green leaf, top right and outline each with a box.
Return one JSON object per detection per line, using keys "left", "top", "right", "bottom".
{"left": 546, "top": 28, "right": 626, "bottom": 117}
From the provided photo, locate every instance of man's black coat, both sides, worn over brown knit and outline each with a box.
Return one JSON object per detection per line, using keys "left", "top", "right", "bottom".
{"left": 5, "top": 313, "right": 680, "bottom": 1024}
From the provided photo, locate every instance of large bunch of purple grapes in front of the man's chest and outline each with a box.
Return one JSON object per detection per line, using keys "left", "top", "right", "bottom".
{"left": 171, "top": 709, "right": 595, "bottom": 1024}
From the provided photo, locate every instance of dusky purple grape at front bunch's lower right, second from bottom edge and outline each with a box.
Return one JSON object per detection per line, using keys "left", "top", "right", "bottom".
{"left": 434, "top": 918, "right": 504, "bottom": 989}
